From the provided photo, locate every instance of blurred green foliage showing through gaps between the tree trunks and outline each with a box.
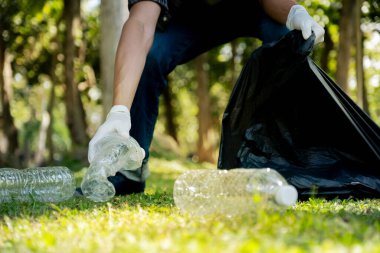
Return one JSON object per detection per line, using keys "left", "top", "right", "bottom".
{"left": 0, "top": 0, "right": 380, "bottom": 165}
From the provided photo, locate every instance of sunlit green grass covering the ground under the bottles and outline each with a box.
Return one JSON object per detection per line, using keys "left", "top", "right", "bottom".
{"left": 0, "top": 157, "right": 380, "bottom": 253}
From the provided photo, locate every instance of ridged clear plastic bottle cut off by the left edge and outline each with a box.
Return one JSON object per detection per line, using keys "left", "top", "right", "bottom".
{"left": 0, "top": 167, "right": 75, "bottom": 203}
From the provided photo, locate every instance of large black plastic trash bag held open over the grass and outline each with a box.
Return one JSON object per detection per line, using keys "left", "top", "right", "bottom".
{"left": 218, "top": 31, "right": 380, "bottom": 199}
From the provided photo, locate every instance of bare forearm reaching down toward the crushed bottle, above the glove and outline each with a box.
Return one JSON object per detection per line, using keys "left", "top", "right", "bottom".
{"left": 113, "top": 1, "right": 161, "bottom": 108}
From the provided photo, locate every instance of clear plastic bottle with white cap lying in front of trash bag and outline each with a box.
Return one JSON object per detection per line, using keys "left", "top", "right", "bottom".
{"left": 173, "top": 168, "right": 298, "bottom": 216}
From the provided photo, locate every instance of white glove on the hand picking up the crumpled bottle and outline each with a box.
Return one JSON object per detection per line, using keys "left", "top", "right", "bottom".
{"left": 88, "top": 105, "right": 131, "bottom": 163}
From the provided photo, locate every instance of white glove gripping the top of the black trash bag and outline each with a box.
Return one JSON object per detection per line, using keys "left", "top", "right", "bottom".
{"left": 286, "top": 5, "right": 325, "bottom": 45}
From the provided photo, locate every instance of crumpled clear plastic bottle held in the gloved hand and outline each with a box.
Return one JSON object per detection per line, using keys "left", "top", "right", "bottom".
{"left": 81, "top": 134, "right": 145, "bottom": 202}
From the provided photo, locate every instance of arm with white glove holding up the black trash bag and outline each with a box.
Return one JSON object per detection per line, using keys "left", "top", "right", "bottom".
{"left": 259, "top": 0, "right": 325, "bottom": 44}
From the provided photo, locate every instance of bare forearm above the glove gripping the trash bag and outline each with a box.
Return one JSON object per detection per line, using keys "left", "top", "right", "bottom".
{"left": 259, "top": 0, "right": 296, "bottom": 24}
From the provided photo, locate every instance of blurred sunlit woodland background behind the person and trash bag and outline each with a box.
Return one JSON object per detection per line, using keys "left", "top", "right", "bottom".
{"left": 0, "top": 0, "right": 380, "bottom": 169}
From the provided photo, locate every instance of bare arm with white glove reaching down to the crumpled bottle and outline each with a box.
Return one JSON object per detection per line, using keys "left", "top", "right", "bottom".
{"left": 88, "top": 1, "right": 161, "bottom": 163}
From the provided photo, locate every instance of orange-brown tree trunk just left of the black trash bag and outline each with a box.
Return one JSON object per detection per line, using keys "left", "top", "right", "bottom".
{"left": 195, "top": 53, "right": 215, "bottom": 163}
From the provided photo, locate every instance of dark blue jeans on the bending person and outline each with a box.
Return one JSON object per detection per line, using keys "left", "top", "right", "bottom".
{"left": 130, "top": 1, "right": 288, "bottom": 181}
